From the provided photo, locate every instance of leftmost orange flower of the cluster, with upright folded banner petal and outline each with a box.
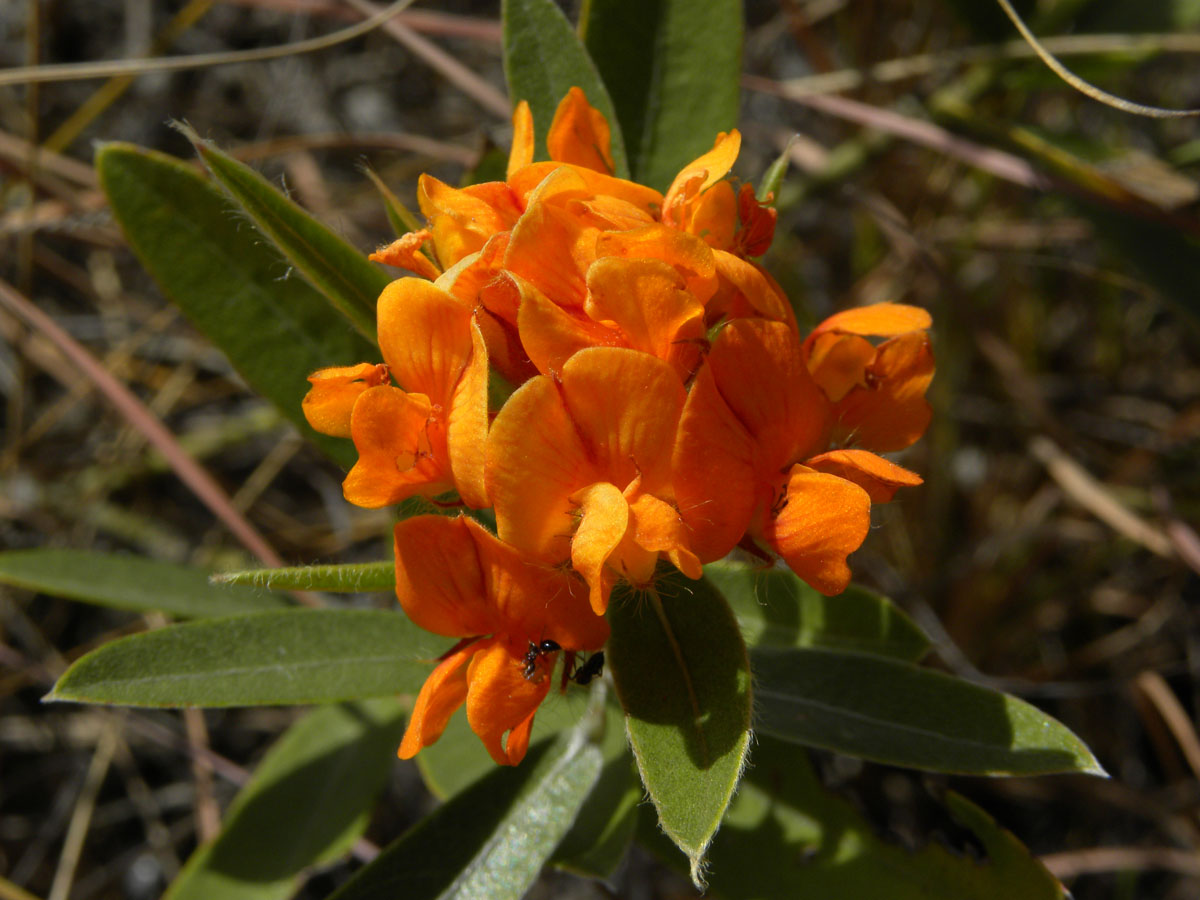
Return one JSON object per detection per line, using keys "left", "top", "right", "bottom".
{"left": 304, "top": 278, "right": 488, "bottom": 508}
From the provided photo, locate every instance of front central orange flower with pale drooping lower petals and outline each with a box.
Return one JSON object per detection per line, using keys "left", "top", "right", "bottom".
{"left": 487, "top": 348, "right": 701, "bottom": 614}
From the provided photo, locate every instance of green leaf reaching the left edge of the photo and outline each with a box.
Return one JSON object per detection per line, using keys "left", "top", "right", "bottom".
{"left": 0, "top": 550, "right": 289, "bottom": 619}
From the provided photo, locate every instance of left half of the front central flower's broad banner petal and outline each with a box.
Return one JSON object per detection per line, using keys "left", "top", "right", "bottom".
{"left": 487, "top": 376, "right": 604, "bottom": 565}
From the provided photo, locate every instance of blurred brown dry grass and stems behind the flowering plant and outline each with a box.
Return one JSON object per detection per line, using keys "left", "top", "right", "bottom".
{"left": 0, "top": 0, "right": 1200, "bottom": 900}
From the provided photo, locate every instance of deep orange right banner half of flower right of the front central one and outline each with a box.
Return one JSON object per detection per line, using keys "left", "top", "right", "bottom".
{"left": 708, "top": 319, "right": 829, "bottom": 481}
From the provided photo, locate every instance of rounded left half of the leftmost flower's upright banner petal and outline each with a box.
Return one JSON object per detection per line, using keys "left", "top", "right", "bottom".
{"left": 376, "top": 278, "right": 474, "bottom": 408}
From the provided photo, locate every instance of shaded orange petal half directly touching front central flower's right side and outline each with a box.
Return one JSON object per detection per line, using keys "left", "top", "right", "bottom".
{"left": 673, "top": 365, "right": 760, "bottom": 563}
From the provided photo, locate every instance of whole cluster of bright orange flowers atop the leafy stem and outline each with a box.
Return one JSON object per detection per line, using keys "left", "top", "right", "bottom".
{"left": 304, "top": 88, "right": 934, "bottom": 764}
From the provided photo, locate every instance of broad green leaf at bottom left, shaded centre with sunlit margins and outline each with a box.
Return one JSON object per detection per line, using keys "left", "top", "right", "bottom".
{"left": 163, "top": 697, "right": 404, "bottom": 900}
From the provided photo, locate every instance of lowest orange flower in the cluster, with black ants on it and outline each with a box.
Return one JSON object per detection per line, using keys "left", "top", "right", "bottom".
{"left": 395, "top": 516, "right": 608, "bottom": 766}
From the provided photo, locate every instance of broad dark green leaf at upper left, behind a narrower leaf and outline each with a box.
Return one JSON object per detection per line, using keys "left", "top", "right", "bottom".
{"left": 96, "top": 144, "right": 369, "bottom": 468}
